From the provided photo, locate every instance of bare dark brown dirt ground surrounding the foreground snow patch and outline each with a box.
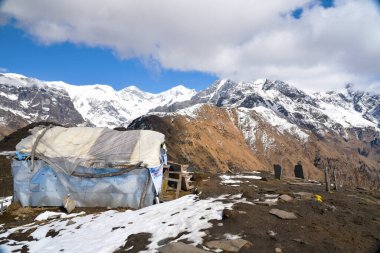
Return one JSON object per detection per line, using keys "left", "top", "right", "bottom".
{"left": 0, "top": 172, "right": 380, "bottom": 252}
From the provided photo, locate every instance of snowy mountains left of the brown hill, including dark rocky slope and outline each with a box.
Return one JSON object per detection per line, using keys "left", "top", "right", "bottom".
{"left": 0, "top": 73, "right": 196, "bottom": 134}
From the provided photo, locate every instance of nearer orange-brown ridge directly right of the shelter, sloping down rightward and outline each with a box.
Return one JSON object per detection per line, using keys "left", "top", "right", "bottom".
{"left": 128, "top": 106, "right": 265, "bottom": 172}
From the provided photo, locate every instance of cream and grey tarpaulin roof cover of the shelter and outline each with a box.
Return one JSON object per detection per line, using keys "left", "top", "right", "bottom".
{"left": 16, "top": 127, "right": 165, "bottom": 175}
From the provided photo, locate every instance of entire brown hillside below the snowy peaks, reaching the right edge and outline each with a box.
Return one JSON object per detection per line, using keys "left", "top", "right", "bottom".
{"left": 128, "top": 105, "right": 380, "bottom": 189}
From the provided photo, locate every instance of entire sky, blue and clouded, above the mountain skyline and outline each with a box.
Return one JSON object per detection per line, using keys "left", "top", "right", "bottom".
{"left": 0, "top": 0, "right": 380, "bottom": 92}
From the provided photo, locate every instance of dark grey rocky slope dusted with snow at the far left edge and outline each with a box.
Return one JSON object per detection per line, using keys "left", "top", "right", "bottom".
{"left": 0, "top": 74, "right": 84, "bottom": 137}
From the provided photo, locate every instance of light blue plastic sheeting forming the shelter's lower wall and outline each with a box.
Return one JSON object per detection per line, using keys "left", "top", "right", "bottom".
{"left": 12, "top": 160, "right": 157, "bottom": 209}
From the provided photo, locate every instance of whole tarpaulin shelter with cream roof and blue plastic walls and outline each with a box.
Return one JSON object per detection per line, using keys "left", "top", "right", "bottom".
{"left": 12, "top": 127, "right": 165, "bottom": 208}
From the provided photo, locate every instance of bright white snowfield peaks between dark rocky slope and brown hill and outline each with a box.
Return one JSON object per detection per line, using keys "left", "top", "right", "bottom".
{"left": 46, "top": 82, "right": 196, "bottom": 128}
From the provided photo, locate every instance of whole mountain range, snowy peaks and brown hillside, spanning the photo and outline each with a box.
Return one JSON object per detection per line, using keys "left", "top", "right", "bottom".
{"left": 0, "top": 74, "right": 380, "bottom": 188}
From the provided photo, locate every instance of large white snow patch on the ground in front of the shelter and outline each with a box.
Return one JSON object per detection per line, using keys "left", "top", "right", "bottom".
{"left": 0, "top": 194, "right": 252, "bottom": 253}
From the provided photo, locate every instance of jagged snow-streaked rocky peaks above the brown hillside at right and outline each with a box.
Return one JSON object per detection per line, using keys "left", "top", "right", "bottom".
{"left": 155, "top": 79, "right": 380, "bottom": 136}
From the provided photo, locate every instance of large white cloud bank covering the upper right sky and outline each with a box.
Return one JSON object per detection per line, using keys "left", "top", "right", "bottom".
{"left": 0, "top": 0, "right": 380, "bottom": 90}
